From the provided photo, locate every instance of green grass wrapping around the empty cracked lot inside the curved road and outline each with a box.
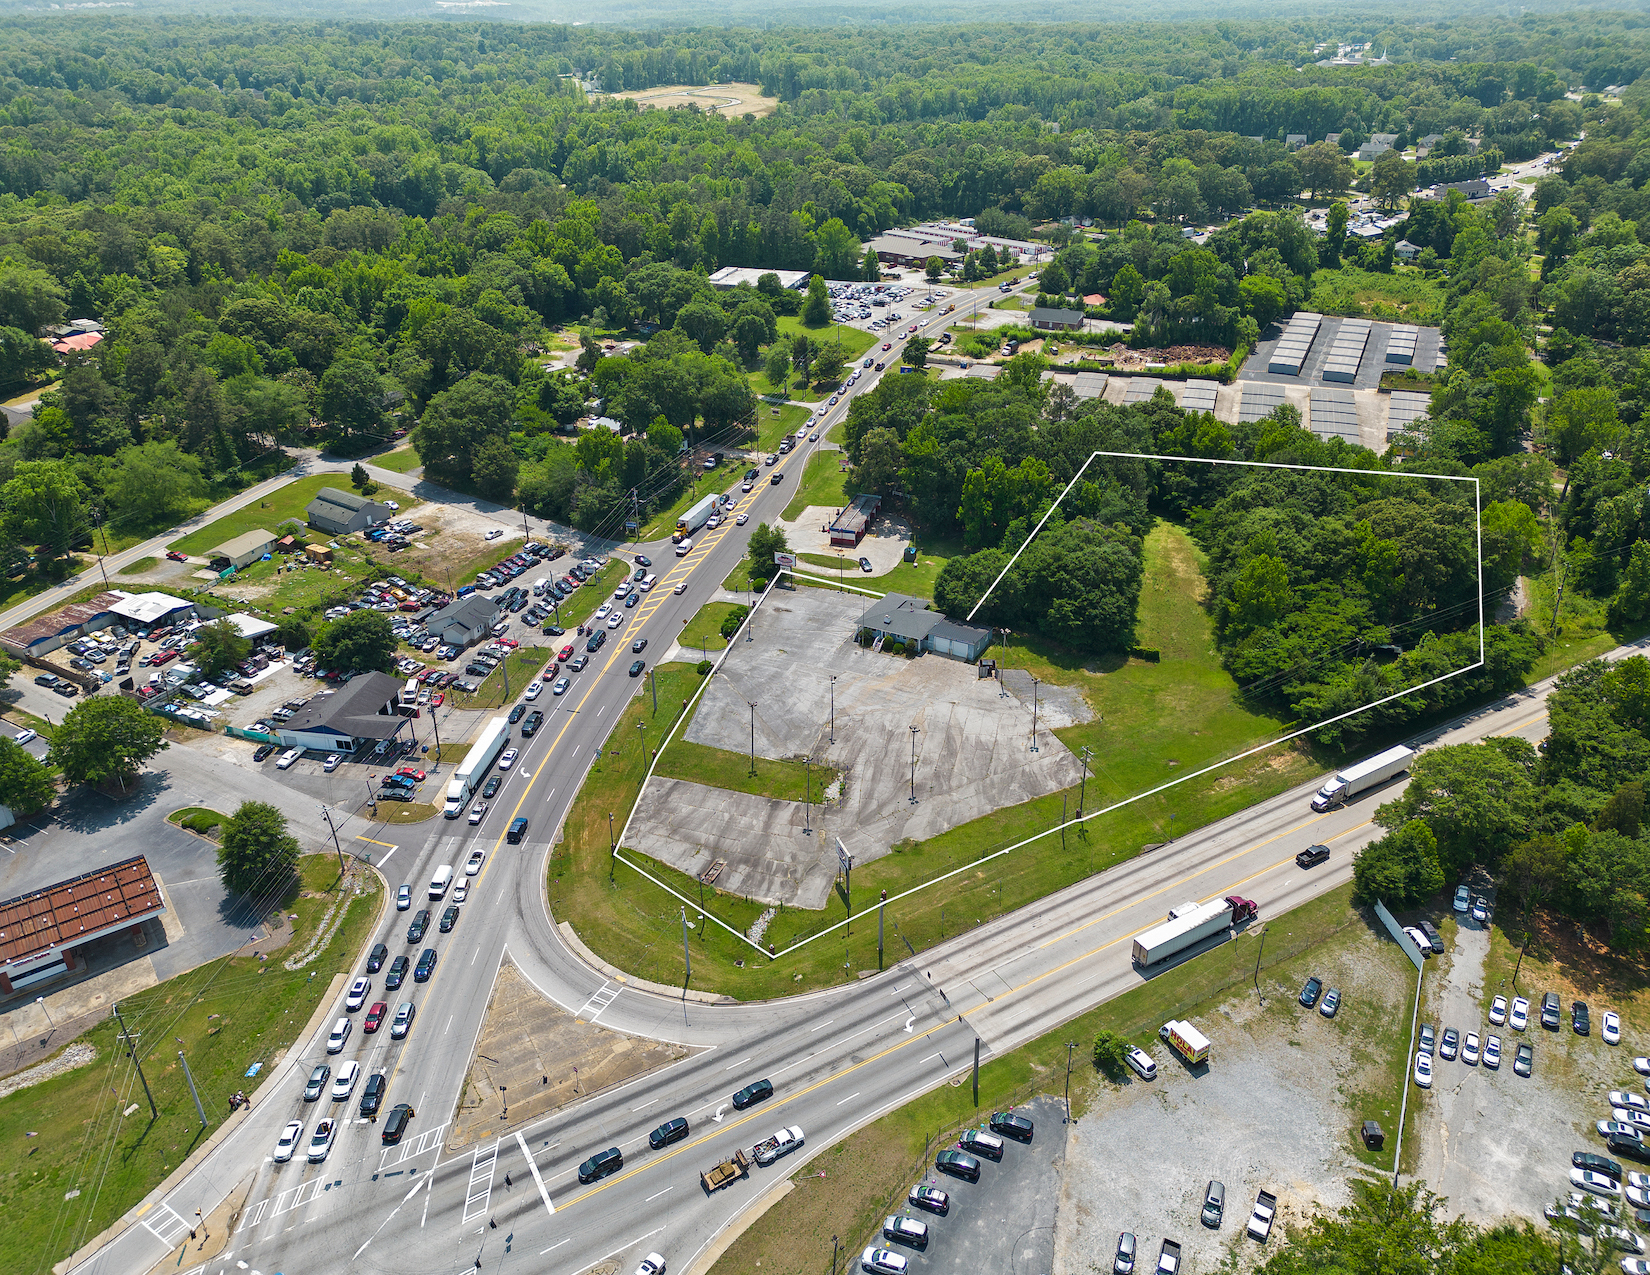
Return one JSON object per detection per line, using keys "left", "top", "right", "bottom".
{"left": 549, "top": 525, "right": 1318, "bottom": 1000}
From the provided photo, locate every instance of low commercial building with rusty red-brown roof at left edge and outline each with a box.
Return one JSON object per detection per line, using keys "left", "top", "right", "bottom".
{"left": 0, "top": 854, "right": 167, "bottom": 996}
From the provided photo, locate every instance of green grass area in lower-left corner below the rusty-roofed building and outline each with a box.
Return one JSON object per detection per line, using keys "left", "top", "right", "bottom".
{"left": 0, "top": 857, "right": 377, "bottom": 1272}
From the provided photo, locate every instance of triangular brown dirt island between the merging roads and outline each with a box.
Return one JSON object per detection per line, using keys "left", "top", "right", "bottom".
{"left": 447, "top": 963, "right": 690, "bottom": 1150}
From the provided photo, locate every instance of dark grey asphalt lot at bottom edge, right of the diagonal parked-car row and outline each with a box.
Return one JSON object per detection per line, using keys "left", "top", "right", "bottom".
{"left": 897, "top": 1097, "right": 1062, "bottom": 1275}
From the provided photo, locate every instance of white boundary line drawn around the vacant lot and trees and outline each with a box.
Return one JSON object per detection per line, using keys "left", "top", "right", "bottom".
{"left": 612, "top": 452, "right": 1485, "bottom": 960}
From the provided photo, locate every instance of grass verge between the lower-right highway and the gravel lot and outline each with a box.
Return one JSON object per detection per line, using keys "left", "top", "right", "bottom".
{"left": 711, "top": 886, "right": 1409, "bottom": 1275}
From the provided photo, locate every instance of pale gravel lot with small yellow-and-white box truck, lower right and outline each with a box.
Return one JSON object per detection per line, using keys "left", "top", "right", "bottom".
{"left": 1053, "top": 930, "right": 1412, "bottom": 1275}
